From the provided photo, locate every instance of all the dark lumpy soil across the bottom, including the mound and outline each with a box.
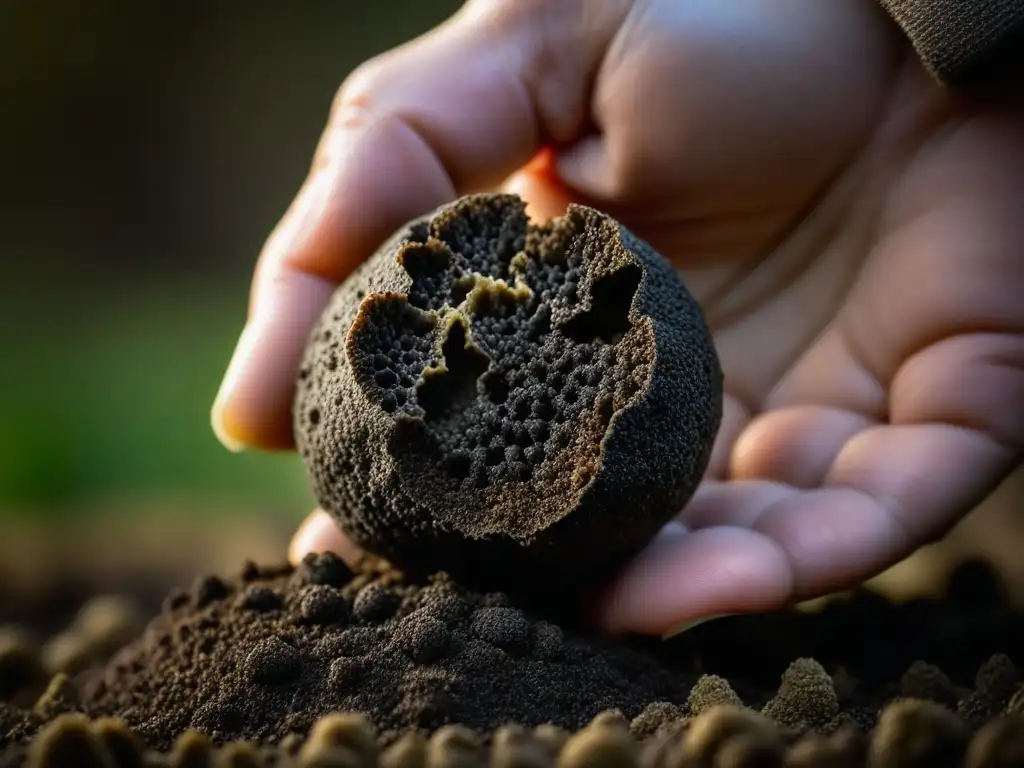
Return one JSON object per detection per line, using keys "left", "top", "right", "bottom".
{"left": 0, "top": 556, "right": 1024, "bottom": 768}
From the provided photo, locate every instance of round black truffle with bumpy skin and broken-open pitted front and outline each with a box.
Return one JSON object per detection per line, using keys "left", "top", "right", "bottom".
{"left": 294, "top": 195, "right": 722, "bottom": 587}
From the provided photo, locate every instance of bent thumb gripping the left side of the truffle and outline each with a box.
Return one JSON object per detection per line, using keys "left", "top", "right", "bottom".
{"left": 211, "top": 0, "right": 628, "bottom": 450}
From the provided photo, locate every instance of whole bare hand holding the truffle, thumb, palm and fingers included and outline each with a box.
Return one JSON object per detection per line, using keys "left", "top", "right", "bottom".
{"left": 213, "top": 0, "right": 1024, "bottom": 634}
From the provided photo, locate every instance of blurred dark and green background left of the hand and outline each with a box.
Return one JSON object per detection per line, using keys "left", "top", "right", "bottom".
{"left": 0, "top": 0, "right": 460, "bottom": 519}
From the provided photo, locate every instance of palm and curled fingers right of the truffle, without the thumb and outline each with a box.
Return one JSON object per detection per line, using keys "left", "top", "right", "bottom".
{"left": 604, "top": 60, "right": 1024, "bottom": 632}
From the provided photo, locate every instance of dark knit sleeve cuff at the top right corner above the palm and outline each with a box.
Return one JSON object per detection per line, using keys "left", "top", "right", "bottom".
{"left": 879, "top": 0, "right": 1024, "bottom": 86}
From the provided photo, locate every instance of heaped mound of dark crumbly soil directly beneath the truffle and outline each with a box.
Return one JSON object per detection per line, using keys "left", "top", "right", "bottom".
{"left": 75, "top": 555, "right": 692, "bottom": 748}
